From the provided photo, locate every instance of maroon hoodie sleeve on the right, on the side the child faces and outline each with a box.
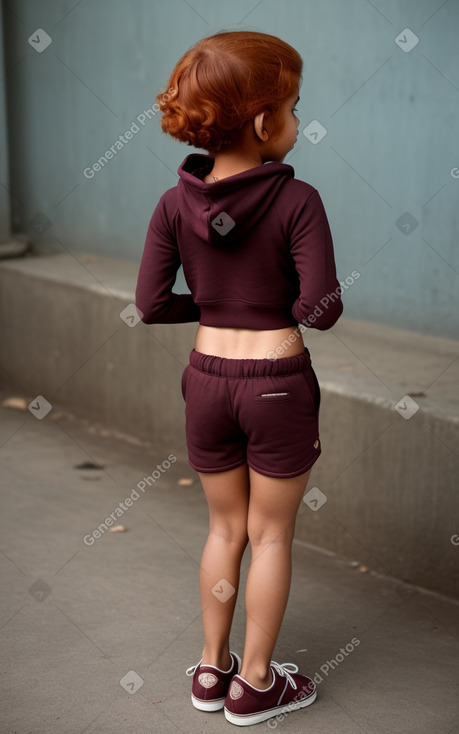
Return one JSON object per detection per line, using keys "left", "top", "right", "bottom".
{"left": 290, "top": 190, "right": 343, "bottom": 331}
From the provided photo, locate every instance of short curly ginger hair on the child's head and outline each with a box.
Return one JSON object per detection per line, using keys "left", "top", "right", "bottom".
{"left": 156, "top": 31, "right": 303, "bottom": 153}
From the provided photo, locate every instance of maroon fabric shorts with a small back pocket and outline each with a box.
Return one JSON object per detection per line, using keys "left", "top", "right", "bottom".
{"left": 182, "top": 348, "right": 321, "bottom": 477}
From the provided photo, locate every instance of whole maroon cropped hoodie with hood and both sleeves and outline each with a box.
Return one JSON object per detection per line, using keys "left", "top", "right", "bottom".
{"left": 136, "top": 153, "right": 343, "bottom": 330}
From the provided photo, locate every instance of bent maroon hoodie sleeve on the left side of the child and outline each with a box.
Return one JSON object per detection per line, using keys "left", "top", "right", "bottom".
{"left": 135, "top": 195, "right": 200, "bottom": 324}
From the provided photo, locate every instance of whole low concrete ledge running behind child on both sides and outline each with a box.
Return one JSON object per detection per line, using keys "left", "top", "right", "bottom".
{"left": 0, "top": 253, "right": 459, "bottom": 597}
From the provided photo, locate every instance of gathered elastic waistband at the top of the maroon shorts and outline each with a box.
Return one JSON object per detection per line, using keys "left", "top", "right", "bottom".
{"left": 190, "top": 347, "right": 311, "bottom": 377}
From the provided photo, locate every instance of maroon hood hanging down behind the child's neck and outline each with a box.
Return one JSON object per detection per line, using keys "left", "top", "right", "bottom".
{"left": 177, "top": 153, "right": 295, "bottom": 246}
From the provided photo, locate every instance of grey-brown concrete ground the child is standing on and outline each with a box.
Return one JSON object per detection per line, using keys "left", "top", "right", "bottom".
{"left": 0, "top": 393, "right": 459, "bottom": 734}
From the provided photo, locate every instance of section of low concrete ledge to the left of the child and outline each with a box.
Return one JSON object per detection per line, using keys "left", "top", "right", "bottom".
{"left": 0, "top": 254, "right": 194, "bottom": 446}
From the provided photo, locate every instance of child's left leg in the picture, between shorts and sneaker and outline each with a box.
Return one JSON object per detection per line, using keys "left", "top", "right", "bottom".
{"left": 199, "top": 464, "right": 249, "bottom": 670}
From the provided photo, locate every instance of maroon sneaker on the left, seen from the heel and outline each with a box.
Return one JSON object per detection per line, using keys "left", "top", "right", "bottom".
{"left": 186, "top": 652, "right": 241, "bottom": 711}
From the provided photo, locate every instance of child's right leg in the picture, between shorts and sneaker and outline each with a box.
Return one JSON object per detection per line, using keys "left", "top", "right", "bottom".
{"left": 241, "top": 469, "right": 310, "bottom": 688}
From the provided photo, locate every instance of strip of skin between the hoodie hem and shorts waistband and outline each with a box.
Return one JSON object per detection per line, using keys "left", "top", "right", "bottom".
{"left": 195, "top": 324, "right": 304, "bottom": 359}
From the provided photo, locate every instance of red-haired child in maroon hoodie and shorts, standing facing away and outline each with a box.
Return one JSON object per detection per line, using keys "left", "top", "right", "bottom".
{"left": 136, "top": 31, "right": 343, "bottom": 726}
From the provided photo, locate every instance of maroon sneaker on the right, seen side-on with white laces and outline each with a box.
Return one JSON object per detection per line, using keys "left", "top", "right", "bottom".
{"left": 225, "top": 660, "right": 317, "bottom": 726}
